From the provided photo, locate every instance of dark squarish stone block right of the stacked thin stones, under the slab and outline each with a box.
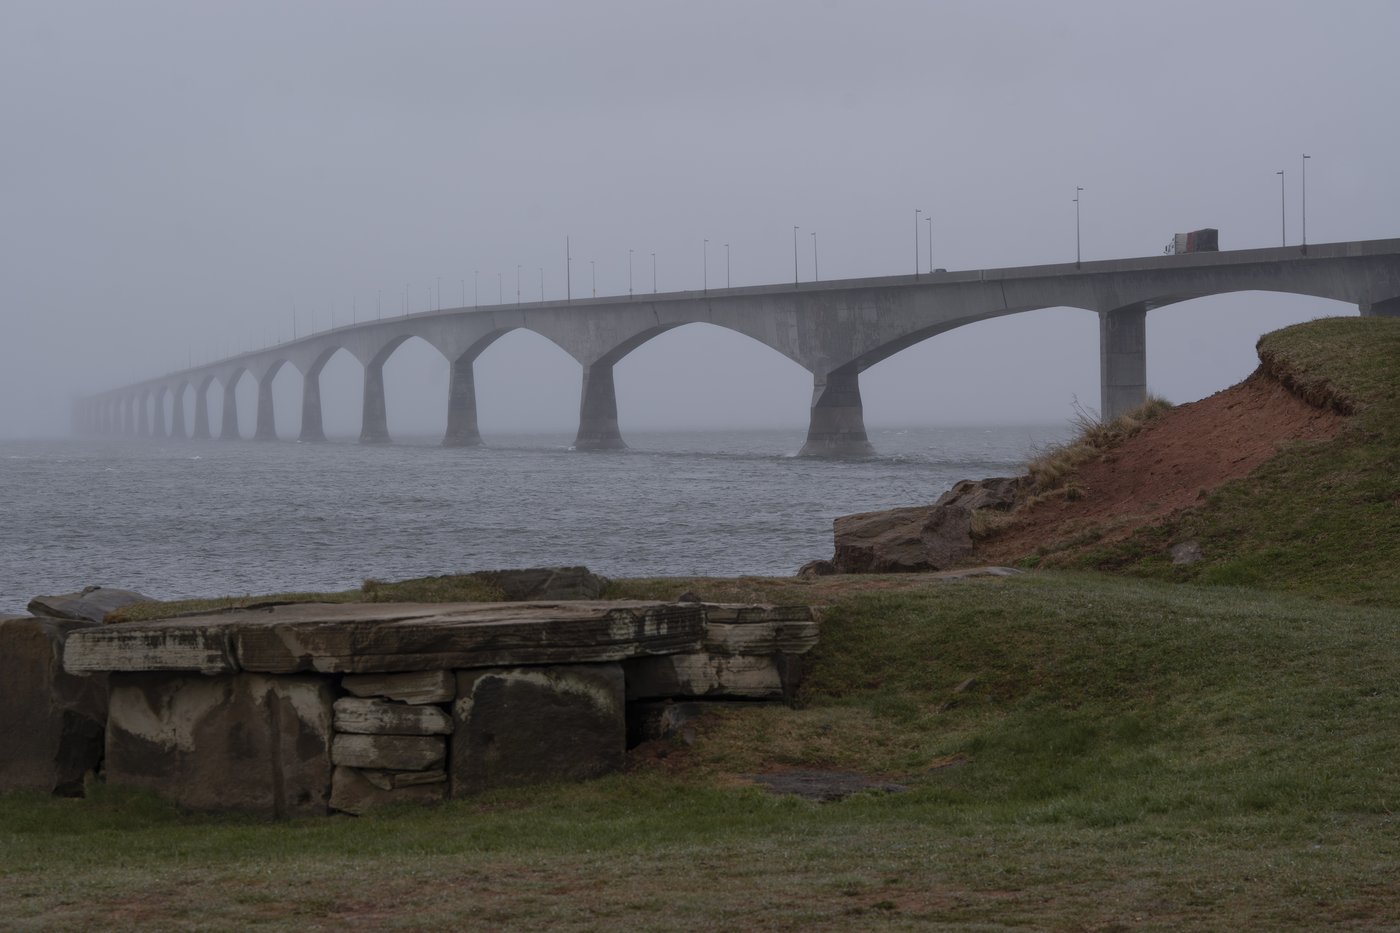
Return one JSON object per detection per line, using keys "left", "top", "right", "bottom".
{"left": 451, "top": 664, "right": 627, "bottom": 797}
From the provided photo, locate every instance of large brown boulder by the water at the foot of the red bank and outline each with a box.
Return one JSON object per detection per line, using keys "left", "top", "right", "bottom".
{"left": 832, "top": 504, "right": 972, "bottom": 573}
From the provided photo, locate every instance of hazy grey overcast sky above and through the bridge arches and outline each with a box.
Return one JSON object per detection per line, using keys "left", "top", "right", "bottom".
{"left": 0, "top": 0, "right": 1400, "bottom": 437}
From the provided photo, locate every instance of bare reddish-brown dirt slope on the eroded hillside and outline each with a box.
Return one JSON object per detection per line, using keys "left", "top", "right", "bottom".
{"left": 972, "top": 371, "right": 1347, "bottom": 563}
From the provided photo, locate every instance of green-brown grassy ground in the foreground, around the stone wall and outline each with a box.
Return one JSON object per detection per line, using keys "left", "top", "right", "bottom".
{"left": 8, "top": 574, "right": 1400, "bottom": 930}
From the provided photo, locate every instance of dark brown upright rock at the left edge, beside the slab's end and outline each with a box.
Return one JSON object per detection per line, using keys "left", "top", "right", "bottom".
{"left": 0, "top": 616, "right": 106, "bottom": 796}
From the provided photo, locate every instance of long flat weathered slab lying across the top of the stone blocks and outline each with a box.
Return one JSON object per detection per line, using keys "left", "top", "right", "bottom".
{"left": 64, "top": 601, "right": 706, "bottom": 674}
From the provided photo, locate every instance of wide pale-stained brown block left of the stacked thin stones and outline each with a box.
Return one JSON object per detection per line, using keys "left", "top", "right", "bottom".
{"left": 105, "top": 672, "right": 335, "bottom": 817}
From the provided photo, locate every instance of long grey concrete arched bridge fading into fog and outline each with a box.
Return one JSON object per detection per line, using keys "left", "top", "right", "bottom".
{"left": 74, "top": 240, "right": 1400, "bottom": 457}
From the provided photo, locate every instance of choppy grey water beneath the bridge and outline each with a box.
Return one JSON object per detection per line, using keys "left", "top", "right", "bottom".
{"left": 0, "top": 426, "right": 1067, "bottom": 614}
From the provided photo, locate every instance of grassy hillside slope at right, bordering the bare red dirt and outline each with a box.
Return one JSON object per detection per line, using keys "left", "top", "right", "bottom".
{"left": 1074, "top": 318, "right": 1400, "bottom": 605}
